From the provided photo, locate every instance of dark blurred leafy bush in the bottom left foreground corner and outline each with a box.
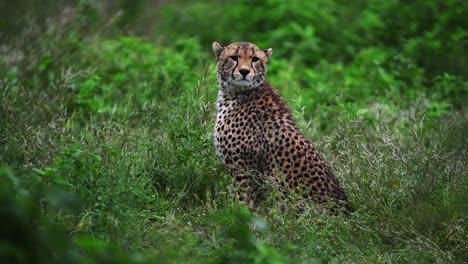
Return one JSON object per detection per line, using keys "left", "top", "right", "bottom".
{"left": 0, "top": 167, "right": 157, "bottom": 263}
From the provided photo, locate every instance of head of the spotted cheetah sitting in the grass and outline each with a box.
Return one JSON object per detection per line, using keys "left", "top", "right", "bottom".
{"left": 213, "top": 42, "right": 273, "bottom": 92}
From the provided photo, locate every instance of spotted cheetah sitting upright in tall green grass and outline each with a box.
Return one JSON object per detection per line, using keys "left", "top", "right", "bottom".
{"left": 212, "top": 42, "right": 352, "bottom": 215}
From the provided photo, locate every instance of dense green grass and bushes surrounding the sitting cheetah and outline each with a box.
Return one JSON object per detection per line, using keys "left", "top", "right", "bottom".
{"left": 0, "top": 0, "right": 468, "bottom": 263}
